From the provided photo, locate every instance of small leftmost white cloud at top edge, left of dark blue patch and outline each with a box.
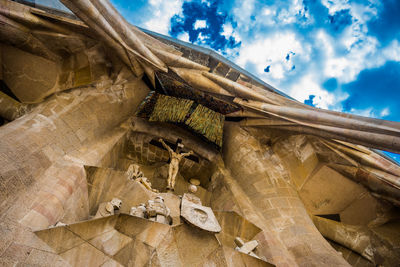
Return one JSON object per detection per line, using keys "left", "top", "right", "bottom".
{"left": 143, "top": 0, "right": 183, "bottom": 34}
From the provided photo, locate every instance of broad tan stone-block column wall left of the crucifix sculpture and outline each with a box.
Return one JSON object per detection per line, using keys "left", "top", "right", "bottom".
{"left": 0, "top": 77, "right": 148, "bottom": 265}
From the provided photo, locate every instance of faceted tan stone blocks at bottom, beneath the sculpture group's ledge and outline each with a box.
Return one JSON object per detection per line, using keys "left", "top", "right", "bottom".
{"left": 36, "top": 214, "right": 233, "bottom": 266}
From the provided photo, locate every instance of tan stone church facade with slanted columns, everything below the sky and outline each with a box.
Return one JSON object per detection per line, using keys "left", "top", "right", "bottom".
{"left": 0, "top": 0, "right": 400, "bottom": 266}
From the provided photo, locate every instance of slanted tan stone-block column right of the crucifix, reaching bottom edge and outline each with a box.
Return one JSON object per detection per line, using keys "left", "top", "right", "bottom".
{"left": 223, "top": 124, "right": 349, "bottom": 266}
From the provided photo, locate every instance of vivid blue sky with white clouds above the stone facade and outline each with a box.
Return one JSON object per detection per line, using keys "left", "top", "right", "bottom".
{"left": 111, "top": 0, "right": 400, "bottom": 160}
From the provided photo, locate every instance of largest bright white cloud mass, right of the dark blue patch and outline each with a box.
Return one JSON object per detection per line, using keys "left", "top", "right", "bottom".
{"left": 224, "top": 0, "right": 400, "bottom": 118}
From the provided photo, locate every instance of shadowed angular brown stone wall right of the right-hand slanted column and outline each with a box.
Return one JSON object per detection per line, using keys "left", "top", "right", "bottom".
{"left": 273, "top": 135, "right": 393, "bottom": 225}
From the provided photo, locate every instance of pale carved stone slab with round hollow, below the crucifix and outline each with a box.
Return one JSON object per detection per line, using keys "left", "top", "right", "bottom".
{"left": 181, "top": 194, "right": 221, "bottom": 233}
